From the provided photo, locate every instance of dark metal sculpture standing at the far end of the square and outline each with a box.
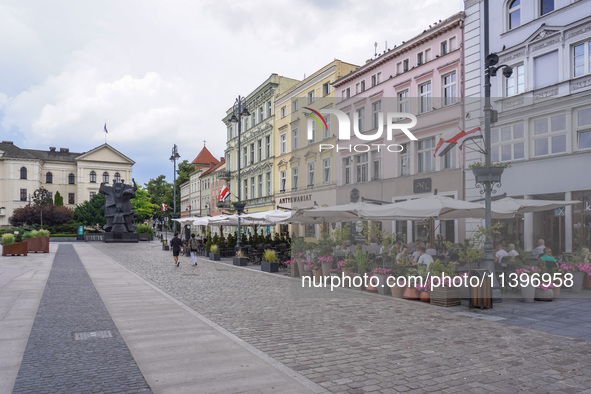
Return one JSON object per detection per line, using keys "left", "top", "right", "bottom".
{"left": 99, "top": 179, "right": 137, "bottom": 233}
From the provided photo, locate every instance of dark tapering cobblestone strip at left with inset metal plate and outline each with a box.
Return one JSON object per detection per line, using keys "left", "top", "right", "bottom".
{"left": 13, "top": 245, "right": 151, "bottom": 393}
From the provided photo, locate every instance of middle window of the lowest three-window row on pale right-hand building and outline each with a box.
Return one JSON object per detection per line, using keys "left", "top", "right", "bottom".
{"left": 533, "top": 114, "right": 566, "bottom": 156}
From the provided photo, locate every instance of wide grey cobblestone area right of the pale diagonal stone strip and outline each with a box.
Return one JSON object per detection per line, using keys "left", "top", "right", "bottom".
{"left": 92, "top": 242, "right": 591, "bottom": 393}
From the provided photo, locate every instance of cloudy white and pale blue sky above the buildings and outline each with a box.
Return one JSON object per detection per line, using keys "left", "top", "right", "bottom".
{"left": 0, "top": 0, "right": 463, "bottom": 184}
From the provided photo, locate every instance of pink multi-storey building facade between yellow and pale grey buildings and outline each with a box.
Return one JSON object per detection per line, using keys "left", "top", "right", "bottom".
{"left": 326, "top": 13, "right": 465, "bottom": 242}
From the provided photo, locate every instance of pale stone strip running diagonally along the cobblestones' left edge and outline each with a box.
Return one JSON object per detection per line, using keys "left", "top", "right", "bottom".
{"left": 90, "top": 245, "right": 329, "bottom": 393}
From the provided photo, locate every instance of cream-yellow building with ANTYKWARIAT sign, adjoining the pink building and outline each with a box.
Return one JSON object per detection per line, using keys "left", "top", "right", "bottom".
{"left": 273, "top": 60, "right": 358, "bottom": 240}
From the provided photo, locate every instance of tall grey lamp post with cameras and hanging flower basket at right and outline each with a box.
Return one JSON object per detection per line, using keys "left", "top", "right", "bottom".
{"left": 477, "top": 0, "right": 513, "bottom": 302}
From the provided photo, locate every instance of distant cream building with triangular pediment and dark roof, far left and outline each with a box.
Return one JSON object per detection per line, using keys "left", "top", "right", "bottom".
{"left": 0, "top": 141, "right": 135, "bottom": 227}
